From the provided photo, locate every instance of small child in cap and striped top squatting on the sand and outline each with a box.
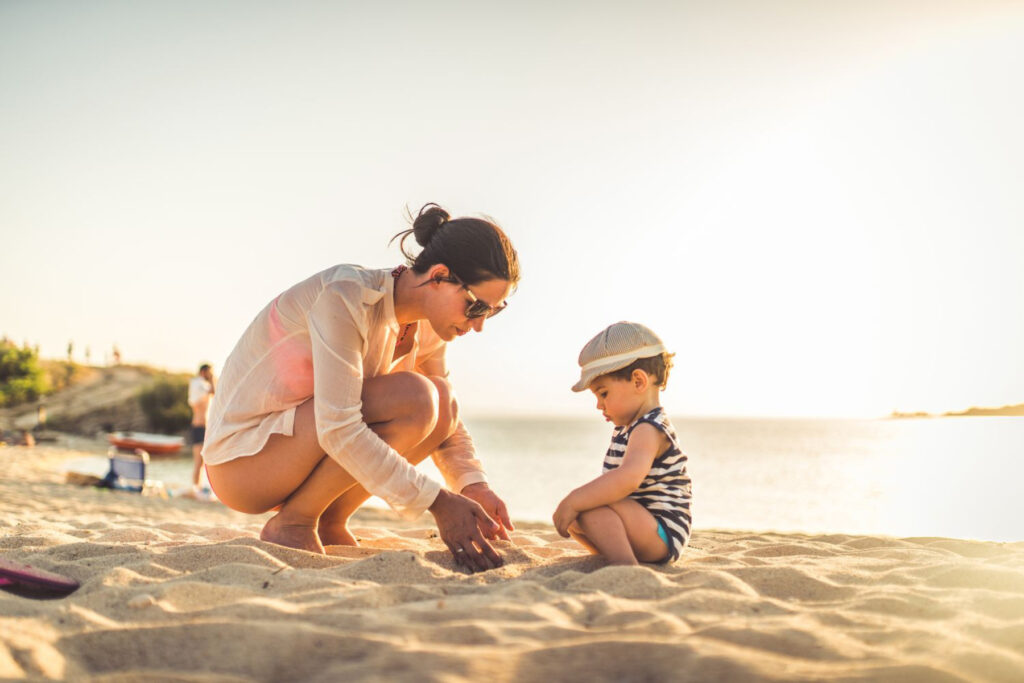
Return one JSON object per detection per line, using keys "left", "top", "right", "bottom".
{"left": 554, "top": 323, "right": 691, "bottom": 564}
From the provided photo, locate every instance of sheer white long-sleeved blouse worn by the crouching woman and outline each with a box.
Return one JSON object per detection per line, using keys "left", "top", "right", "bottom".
{"left": 203, "top": 265, "right": 486, "bottom": 518}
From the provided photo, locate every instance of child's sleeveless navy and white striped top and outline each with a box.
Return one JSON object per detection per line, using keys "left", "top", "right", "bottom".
{"left": 604, "top": 405, "right": 693, "bottom": 562}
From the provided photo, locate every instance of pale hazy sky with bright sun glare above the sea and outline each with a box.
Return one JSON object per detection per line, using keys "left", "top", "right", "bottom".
{"left": 0, "top": 0, "right": 1024, "bottom": 417}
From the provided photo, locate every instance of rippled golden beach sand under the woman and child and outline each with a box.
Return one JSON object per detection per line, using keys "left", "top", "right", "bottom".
{"left": 0, "top": 446, "right": 1024, "bottom": 682}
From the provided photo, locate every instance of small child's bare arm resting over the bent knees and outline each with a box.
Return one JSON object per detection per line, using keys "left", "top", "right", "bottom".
{"left": 554, "top": 423, "right": 667, "bottom": 538}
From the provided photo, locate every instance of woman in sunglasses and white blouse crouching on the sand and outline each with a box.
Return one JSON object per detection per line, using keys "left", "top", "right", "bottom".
{"left": 203, "top": 204, "right": 519, "bottom": 570}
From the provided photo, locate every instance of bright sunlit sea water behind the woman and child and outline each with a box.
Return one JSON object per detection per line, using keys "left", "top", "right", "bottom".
{"left": 136, "top": 416, "right": 1024, "bottom": 541}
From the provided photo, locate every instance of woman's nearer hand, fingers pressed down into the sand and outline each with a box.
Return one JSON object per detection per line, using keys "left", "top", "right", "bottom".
{"left": 429, "top": 488, "right": 503, "bottom": 571}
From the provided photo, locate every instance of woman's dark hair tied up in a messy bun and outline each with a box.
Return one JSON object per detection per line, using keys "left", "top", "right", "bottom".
{"left": 388, "top": 203, "right": 519, "bottom": 287}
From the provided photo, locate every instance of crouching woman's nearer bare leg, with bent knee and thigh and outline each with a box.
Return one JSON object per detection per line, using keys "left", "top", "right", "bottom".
{"left": 208, "top": 373, "right": 458, "bottom": 552}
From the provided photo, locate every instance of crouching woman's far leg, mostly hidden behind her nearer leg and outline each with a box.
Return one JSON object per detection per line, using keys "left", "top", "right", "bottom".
{"left": 316, "top": 377, "right": 459, "bottom": 546}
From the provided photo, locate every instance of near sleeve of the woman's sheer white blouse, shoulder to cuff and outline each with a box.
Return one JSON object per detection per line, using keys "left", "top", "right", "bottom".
{"left": 306, "top": 281, "right": 440, "bottom": 519}
